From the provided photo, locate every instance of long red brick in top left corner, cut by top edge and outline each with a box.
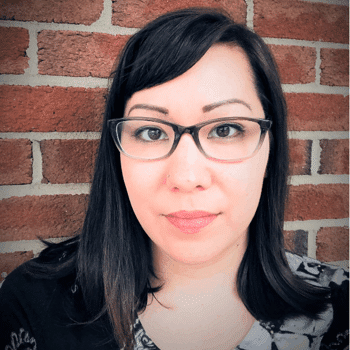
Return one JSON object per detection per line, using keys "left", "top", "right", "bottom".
{"left": 0, "top": 0, "right": 103, "bottom": 24}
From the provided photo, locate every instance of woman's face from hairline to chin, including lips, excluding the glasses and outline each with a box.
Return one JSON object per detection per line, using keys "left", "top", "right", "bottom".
{"left": 121, "top": 45, "right": 269, "bottom": 264}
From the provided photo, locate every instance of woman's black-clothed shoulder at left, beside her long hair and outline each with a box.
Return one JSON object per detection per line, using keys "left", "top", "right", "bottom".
{"left": 0, "top": 259, "right": 116, "bottom": 350}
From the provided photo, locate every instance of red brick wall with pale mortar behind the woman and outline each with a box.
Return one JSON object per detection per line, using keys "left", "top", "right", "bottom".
{"left": 0, "top": 0, "right": 349, "bottom": 278}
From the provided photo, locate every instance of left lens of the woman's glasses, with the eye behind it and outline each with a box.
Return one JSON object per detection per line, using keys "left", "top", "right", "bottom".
{"left": 115, "top": 120, "right": 175, "bottom": 159}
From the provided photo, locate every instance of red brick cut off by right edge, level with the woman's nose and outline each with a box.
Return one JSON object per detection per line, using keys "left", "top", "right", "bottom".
{"left": 318, "top": 140, "right": 349, "bottom": 174}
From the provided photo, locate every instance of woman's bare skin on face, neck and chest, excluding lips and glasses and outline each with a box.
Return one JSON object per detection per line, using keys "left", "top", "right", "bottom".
{"left": 121, "top": 45, "right": 269, "bottom": 349}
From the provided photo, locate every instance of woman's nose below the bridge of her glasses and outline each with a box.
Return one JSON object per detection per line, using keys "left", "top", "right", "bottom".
{"left": 166, "top": 133, "right": 212, "bottom": 193}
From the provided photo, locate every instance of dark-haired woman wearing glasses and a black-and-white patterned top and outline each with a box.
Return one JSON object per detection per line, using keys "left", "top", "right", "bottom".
{"left": 1, "top": 9, "right": 348, "bottom": 350}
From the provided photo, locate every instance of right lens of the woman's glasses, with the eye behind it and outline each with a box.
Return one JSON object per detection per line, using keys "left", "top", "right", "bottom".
{"left": 199, "top": 119, "right": 261, "bottom": 160}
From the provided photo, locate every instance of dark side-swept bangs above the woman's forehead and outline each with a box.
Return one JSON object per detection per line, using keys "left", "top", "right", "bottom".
{"left": 123, "top": 9, "right": 234, "bottom": 96}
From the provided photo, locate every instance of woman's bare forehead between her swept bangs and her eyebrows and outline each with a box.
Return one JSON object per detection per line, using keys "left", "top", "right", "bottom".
{"left": 125, "top": 44, "right": 263, "bottom": 117}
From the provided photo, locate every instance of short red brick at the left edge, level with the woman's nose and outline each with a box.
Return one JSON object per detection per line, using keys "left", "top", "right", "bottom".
{"left": 0, "top": 139, "right": 32, "bottom": 185}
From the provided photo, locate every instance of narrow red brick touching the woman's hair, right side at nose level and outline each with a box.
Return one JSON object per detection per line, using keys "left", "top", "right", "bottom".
{"left": 289, "top": 139, "right": 312, "bottom": 175}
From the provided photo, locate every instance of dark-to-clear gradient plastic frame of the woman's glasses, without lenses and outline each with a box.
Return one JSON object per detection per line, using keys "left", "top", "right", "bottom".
{"left": 107, "top": 117, "right": 272, "bottom": 162}
